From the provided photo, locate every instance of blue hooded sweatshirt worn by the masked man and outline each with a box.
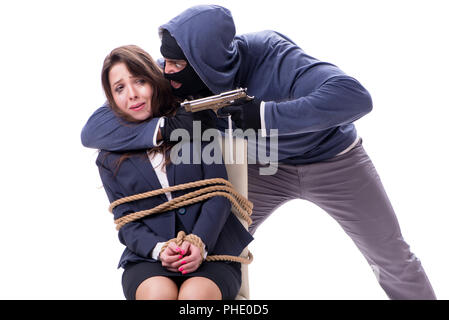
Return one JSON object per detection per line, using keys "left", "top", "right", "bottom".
{"left": 82, "top": 5, "right": 372, "bottom": 164}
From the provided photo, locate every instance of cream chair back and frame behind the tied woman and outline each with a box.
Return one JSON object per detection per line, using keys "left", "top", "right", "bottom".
{"left": 221, "top": 136, "right": 249, "bottom": 300}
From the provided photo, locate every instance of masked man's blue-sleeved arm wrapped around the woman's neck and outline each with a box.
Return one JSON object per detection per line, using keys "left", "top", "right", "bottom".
{"left": 81, "top": 103, "right": 162, "bottom": 151}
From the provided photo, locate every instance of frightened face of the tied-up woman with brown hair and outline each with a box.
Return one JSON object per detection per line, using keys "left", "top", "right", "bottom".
{"left": 109, "top": 62, "right": 153, "bottom": 120}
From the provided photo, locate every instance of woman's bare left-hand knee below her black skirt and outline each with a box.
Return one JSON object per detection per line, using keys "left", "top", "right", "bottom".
{"left": 136, "top": 276, "right": 178, "bottom": 300}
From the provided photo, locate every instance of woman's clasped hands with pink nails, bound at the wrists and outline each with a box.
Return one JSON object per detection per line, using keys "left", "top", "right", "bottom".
{"left": 159, "top": 241, "right": 203, "bottom": 274}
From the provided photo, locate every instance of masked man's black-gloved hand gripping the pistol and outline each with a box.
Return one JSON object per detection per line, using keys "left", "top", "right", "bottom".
{"left": 218, "top": 98, "right": 262, "bottom": 132}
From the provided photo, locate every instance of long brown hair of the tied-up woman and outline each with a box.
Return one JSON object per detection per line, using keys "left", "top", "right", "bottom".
{"left": 101, "top": 45, "right": 178, "bottom": 168}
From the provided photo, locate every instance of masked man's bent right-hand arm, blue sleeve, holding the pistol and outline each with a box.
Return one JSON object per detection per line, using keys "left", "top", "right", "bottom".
{"left": 226, "top": 31, "right": 372, "bottom": 135}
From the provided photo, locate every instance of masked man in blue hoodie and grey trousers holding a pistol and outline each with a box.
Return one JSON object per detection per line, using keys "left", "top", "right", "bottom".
{"left": 83, "top": 6, "right": 435, "bottom": 299}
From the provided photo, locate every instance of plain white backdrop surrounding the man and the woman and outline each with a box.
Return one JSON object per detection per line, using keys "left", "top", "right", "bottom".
{"left": 0, "top": 0, "right": 449, "bottom": 299}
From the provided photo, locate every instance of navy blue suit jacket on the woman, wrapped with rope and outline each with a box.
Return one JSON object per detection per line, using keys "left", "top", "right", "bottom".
{"left": 96, "top": 144, "right": 253, "bottom": 267}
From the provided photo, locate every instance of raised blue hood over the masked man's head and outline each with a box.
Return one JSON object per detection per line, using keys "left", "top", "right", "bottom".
{"left": 159, "top": 5, "right": 240, "bottom": 94}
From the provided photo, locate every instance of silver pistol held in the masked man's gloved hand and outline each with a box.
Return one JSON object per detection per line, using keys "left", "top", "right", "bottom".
{"left": 181, "top": 88, "right": 254, "bottom": 116}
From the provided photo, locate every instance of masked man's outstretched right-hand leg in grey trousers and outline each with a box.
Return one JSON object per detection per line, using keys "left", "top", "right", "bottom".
{"left": 297, "top": 143, "right": 436, "bottom": 299}
